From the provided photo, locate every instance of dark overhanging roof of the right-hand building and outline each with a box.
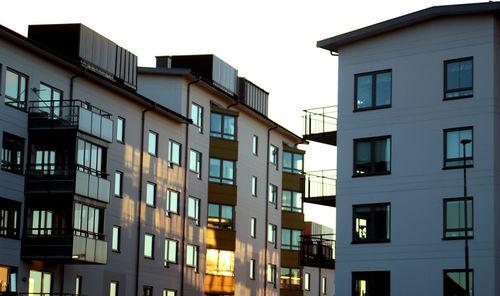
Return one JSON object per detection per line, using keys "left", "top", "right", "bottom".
{"left": 316, "top": 2, "right": 500, "bottom": 52}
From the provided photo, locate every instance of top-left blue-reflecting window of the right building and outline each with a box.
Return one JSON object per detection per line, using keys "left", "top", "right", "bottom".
{"left": 354, "top": 70, "right": 392, "bottom": 111}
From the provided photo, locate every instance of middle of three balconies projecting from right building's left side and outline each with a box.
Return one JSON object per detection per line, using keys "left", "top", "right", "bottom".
{"left": 304, "top": 170, "right": 337, "bottom": 207}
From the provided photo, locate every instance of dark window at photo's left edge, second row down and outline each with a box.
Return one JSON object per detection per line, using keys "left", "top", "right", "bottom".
{"left": 2, "top": 132, "right": 24, "bottom": 174}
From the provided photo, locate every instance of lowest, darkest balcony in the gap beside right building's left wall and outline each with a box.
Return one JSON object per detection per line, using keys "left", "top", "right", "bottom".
{"left": 300, "top": 234, "right": 335, "bottom": 269}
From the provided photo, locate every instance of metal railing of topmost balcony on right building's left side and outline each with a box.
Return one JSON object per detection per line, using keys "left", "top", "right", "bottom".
{"left": 302, "top": 106, "right": 338, "bottom": 135}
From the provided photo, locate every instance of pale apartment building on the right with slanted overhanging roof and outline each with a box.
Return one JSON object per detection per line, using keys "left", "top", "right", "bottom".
{"left": 312, "top": 2, "right": 500, "bottom": 295}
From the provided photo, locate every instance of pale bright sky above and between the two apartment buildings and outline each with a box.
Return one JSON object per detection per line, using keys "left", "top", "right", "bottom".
{"left": 0, "top": 0, "right": 485, "bottom": 227}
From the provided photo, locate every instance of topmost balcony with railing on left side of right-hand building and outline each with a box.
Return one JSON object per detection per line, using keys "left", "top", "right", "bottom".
{"left": 302, "top": 106, "right": 338, "bottom": 146}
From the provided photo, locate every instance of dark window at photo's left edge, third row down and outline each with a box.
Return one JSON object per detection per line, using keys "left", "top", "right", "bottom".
{"left": 0, "top": 198, "right": 21, "bottom": 238}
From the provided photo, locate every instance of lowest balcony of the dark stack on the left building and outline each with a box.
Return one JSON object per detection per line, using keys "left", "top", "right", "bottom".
{"left": 21, "top": 228, "right": 108, "bottom": 264}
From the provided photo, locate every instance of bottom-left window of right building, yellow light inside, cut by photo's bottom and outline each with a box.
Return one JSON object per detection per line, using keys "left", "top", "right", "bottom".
{"left": 352, "top": 271, "right": 391, "bottom": 296}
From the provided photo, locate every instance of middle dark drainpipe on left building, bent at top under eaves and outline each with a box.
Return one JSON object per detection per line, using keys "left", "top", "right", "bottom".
{"left": 180, "top": 76, "right": 200, "bottom": 296}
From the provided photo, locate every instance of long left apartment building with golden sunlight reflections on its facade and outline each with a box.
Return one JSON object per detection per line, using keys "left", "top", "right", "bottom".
{"left": 0, "top": 24, "right": 310, "bottom": 296}
